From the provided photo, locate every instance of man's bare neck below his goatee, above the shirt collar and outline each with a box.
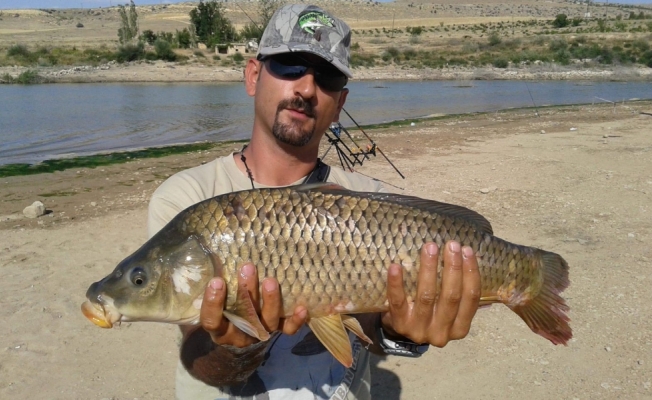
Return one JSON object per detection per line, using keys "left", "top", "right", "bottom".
{"left": 234, "top": 135, "right": 318, "bottom": 186}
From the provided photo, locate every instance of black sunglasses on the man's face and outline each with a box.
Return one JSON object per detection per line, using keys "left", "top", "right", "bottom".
{"left": 263, "top": 54, "right": 349, "bottom": 92}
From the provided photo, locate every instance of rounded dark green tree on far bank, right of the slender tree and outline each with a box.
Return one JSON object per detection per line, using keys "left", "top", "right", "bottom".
{"left": 190, "top": 0, "right": 238, "bottom": 47}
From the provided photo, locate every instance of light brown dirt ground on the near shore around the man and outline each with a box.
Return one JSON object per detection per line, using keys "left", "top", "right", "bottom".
{"left": 0, "top": 102, "right": 652, "bottom": 399}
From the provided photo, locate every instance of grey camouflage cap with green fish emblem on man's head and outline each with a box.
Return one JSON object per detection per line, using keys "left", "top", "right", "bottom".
{"left": 257, "top": 4, "right": 353, "bottom": 78}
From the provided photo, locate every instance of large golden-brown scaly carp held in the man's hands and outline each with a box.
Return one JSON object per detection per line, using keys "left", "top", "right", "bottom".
{"left": 82, "top": 184, "right": 572, "bottom": 365}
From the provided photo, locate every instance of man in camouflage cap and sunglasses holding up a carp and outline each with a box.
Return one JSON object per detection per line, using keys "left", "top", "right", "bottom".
{"left": 148, "top": 5, "right": 480, "bottom": 399}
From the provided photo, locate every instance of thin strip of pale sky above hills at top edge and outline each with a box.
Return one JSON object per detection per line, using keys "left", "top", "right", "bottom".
{"left": 0, "top": 0, "right": 652, "bottom": 9}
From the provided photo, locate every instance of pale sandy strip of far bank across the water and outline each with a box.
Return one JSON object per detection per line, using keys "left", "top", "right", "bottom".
{"left": 0, "top": 61, "right": 652, "bottom": 83}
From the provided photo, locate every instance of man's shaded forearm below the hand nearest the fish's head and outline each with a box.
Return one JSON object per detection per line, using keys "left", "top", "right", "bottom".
{"left": 180, "top": 328, "right": 268, "bottom": 387}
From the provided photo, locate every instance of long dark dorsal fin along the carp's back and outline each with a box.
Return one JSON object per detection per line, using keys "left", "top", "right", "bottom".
{"left": 297, "top": 183, "right": 493, "bottom": 235}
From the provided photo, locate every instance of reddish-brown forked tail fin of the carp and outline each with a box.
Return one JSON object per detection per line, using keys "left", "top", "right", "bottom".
{"left": 507, "top": 250, "right": 573, "bottom": 345}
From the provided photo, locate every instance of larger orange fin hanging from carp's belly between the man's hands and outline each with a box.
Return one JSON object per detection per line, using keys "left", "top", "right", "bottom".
{"left": 308, "top": 314, "right": 354, "bottom": 368}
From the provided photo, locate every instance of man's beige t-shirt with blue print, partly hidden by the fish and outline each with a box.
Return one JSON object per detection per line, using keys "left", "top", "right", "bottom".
{"left": 147, "top": 154, "right": 384, "bottom": 400}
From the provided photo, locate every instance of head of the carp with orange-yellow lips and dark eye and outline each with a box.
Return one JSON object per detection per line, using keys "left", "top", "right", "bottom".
{"left": 82, "top": 235, "right": 216, "bottom": 328}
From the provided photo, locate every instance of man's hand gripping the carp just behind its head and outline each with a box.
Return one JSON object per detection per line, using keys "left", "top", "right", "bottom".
{"left": 200, "top": 263, "right": 308, "bottom": 347}
